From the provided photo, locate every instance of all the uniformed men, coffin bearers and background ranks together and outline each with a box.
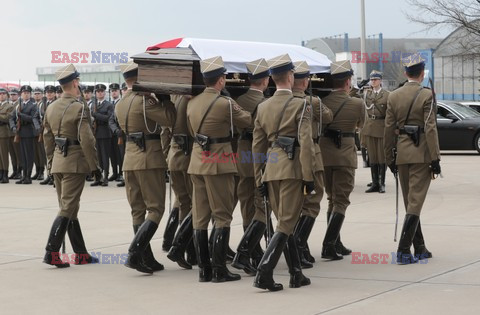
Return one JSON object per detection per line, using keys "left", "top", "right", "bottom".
{"left": 0, "top": 50, "right": 440, "bottom": 291}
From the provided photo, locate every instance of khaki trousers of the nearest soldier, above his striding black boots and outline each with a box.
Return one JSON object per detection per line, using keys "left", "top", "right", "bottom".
{"left": 268, "top": 179, "right": 304, "bottom": 235}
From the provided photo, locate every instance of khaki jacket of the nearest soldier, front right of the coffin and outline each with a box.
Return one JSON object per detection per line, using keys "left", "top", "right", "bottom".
{"left": 252, "top": 90, "right": 315, "bottom": 186}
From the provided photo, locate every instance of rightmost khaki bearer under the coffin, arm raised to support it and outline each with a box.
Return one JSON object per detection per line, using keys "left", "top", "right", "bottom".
{"left": 320, "top": 60, "right": 365, "bottom": 260}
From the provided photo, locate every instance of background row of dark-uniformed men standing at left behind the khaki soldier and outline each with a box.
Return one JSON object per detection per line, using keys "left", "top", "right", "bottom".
{"left": 0, "top": 83, "right": 126, "bottom": 187}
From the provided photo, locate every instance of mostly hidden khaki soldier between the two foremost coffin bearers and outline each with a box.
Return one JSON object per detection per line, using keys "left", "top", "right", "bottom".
{"left": 232, "top": 58, "right": 270, "bottom": 276}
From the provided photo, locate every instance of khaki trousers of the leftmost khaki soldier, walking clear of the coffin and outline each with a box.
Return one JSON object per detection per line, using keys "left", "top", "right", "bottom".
{"left": 53, "top": 173, "right": 85, "bottom": 220}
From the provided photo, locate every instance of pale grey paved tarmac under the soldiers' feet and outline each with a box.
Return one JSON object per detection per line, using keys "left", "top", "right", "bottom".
{"left": 0, "top": 152, "right": 480, "bottom": 314}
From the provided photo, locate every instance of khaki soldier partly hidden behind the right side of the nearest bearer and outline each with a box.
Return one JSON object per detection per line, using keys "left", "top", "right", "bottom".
{"left": 292, "top": 61, "right": 333, "bottom": 268}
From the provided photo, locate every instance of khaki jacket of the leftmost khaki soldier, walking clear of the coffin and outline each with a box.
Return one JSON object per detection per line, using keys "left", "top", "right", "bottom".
{"left": 43, "top": 93, "right": 98, "bottom": 174}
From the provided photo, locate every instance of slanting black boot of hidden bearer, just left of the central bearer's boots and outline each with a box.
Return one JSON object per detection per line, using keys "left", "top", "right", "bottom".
{"left": 167, "top": 212, "right": 193, "bottom": 269}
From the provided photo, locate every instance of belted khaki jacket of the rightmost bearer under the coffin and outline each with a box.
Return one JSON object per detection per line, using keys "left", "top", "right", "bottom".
{"left": 320, "top": 91, "right": 365, "bottom": 168}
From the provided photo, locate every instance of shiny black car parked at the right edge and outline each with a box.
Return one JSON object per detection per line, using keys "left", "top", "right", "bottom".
{"left": 437, "top": 101, "right": 480, "bottom": 153}
